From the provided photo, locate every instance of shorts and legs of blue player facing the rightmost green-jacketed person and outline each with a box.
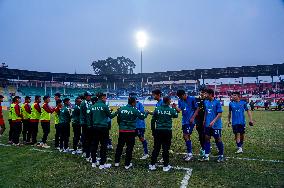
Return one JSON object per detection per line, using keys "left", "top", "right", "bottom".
{"left": 182, "top": 124, "right": 194, "bottom": 161}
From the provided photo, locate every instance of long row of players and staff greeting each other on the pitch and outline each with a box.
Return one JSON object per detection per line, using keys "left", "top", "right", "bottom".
{"left": 0, "top": 89, "right": 253, "bottom": 171}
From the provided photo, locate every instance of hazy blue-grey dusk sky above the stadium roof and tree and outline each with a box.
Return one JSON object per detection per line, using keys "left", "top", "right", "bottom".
{"left": 0, "top": 0, "right": 284, "bottom": 73}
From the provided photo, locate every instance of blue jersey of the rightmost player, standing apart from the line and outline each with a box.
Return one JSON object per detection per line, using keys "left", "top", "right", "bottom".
{"left": 229, "top": 101, "right": 248, "bottom": 126}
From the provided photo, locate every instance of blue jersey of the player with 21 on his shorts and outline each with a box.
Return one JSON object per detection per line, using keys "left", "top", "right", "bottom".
{"left": 204, "top": 99, "right": 223, "bottom": 129}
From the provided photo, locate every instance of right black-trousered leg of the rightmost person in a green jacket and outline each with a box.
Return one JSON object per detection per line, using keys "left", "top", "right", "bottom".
{"left": 162, "top": 131, "right": 172, "bottom": 172}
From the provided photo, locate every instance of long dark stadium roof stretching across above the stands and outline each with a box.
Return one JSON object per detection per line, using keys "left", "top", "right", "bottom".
{"left": 0, "top": 63, "right": 284, "bottom": 83}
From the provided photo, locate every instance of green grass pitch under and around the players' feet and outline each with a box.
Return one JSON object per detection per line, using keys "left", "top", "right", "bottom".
{"left": 0, "top": 107, "right": 284, "bottom": 188}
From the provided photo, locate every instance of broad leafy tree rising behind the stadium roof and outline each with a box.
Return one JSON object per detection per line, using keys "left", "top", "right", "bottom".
{"left": 91, "top": 56, "right": 136, "bottom": 75}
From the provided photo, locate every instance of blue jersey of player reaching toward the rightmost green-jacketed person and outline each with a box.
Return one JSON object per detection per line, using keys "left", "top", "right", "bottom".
{"left": 178, "top": 96, "right": 198, "bottom": 125}
